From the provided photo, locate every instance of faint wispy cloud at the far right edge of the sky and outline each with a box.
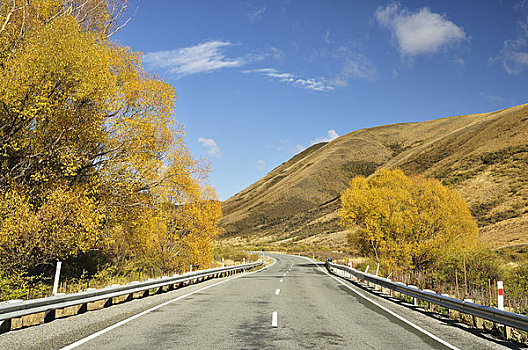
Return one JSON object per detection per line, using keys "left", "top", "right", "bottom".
{"left": 493, "top": 1, "right": 528, "bottom": 75}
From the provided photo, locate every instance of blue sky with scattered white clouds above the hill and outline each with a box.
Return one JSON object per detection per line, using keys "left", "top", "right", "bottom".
{"left": 116, "top": 0, "right": 528, "bottom": 200}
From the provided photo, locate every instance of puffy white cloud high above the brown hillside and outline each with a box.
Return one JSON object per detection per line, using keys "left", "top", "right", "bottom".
{"left": 375, "top": 4, "right": 468, "bottom": 56}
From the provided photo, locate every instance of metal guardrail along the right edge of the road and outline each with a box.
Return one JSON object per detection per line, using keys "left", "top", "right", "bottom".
{"left": 326, "top": 261, "right": 528, "bottom": 331}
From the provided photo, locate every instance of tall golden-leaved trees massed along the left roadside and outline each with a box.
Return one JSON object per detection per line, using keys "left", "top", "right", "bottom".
{"left": 0, "top": 0, "right": 220, "bottom": 273}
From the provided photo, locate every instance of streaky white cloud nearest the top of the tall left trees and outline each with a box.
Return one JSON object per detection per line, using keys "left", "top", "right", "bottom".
{"left": 144, "top": 41, "right": 244, "bottom": 76}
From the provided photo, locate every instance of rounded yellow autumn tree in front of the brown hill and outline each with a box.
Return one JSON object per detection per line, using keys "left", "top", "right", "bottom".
{"left": 340, "top": 169, "right": 478, "bottom": 270}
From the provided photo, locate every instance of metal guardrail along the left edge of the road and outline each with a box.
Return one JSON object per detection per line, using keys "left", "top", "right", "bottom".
{"left": 0, "top": 261, "right": 263, "bottom": 333}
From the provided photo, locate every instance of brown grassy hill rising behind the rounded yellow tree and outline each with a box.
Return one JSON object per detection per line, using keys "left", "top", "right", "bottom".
{"left": 221, "top": 104, "right": 528, "bottom": 247}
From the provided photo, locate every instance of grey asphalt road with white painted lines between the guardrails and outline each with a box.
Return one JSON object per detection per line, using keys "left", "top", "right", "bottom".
{"left": 0, "top": 254, "right": 518, "bottom": 349}
